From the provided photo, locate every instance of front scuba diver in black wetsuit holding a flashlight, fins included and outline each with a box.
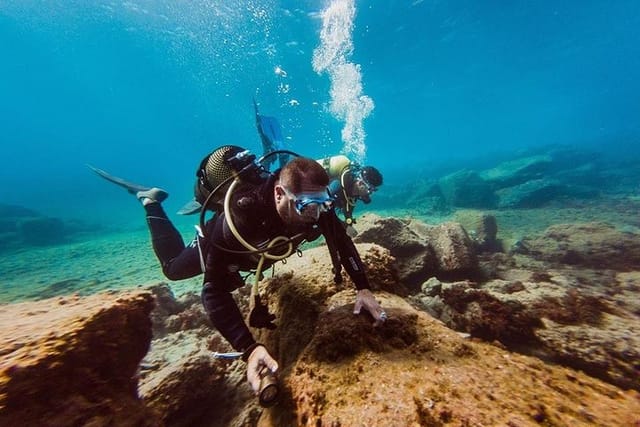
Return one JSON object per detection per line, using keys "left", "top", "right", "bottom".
{"left": 89, "top": 145, "right": 387, "bottom": 406}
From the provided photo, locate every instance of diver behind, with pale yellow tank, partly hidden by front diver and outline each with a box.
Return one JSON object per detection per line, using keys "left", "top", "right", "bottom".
{"left": 318, "top": 155, "right": 382, "bottom": 237}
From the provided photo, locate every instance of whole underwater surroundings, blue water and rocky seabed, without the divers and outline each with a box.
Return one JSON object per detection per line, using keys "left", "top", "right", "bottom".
{"left": 0, "top": 0, "right": 640, "bottom": 427}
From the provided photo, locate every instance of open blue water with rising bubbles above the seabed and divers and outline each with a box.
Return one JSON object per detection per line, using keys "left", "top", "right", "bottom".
{"left": 0, "top": 0, "right": 640, "bottom": 225}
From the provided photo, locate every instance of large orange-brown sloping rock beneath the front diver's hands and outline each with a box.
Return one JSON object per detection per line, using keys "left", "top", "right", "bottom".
{"left": 254, "top": 249, "right": 640, "bottom": 427}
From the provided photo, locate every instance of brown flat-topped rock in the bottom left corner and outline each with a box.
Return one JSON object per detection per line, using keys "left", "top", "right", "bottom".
{"left": 0, "top": 291, "right": 158, "bottom": 426}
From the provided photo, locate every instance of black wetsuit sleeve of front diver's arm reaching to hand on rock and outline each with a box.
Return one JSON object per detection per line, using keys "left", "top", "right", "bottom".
{"left": 319, "top": 210, "right": 371, "bottom": 289}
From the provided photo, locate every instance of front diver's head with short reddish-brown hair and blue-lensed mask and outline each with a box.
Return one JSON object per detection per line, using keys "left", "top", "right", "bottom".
{"left": 273, "top": 157, "right": 333, "bottom": 224}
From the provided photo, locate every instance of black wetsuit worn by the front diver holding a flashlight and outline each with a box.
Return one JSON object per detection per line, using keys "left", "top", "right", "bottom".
{"left": 146, "top": 176, "right": 369, "bottom": 351}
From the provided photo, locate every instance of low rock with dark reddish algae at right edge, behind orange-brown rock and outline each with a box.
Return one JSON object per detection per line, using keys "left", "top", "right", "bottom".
{"left": 412, "top": 254, "right": 640, "bottom": 390}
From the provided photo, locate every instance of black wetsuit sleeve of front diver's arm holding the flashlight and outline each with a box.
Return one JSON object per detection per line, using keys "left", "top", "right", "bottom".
{"left": 202, "top": 214, "right": 255, "bottom": 351}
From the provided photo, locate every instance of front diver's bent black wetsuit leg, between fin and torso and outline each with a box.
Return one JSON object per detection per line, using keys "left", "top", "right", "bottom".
{"left": 144, "top": 203, "right": 202, "bottom": 280}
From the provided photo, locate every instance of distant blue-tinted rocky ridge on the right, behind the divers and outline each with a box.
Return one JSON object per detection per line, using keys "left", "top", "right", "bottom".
{"left": 388, "top": 146, "right": 638, "bottom": 217}
